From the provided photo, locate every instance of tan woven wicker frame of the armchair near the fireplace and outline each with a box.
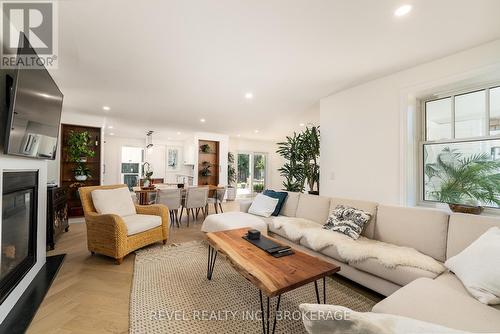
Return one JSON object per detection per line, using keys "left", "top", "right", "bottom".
{"left": 79, "top": 184, "right": 170, "bottom": 264}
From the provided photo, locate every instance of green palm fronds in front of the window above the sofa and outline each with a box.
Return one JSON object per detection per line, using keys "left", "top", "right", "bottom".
{"left": 424, "top": 147, "right": 500, "bottom": 207}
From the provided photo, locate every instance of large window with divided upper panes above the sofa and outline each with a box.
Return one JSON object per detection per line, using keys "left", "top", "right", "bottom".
{"left": 421, "top": 87, "right": 500, "bottom": 208}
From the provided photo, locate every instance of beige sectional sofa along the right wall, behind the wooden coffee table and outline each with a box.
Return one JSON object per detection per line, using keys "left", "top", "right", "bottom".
{"left": 202, "top": 193, "right": 500, "bottom": 332}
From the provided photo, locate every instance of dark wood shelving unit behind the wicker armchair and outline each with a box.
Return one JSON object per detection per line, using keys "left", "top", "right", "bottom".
{"left": 60, "top": 124, "right": 101, "bottom": 217}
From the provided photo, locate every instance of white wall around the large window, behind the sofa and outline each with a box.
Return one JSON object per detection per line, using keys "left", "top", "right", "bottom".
{"left": 320, "top": 40, "right": 500, "bottom": 205}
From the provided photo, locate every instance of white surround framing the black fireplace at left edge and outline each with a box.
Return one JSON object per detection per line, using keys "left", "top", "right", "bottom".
{"left": 0, "top": 154, "right": 47, "bottom": 323}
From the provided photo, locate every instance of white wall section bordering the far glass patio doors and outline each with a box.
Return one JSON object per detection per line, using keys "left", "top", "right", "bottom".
{"left": 229, "top": 137, "right": 284, "bottom": 189}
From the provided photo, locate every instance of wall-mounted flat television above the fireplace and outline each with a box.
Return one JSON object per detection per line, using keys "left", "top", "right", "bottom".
{"left": 4, "top": 33, "right": 63, "bottom": 160}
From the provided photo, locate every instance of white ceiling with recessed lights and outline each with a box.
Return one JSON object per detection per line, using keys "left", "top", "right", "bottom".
{"left": 52, "top": 0, "right": 500, "bottom": 140}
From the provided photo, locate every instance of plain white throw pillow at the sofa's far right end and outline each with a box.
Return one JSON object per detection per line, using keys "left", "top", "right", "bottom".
{"left": 444, "top": 227, "right": 500, "bottom": 305}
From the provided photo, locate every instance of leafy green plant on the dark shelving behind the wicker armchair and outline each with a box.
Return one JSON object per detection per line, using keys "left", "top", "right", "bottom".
{"left": 68, "top": 131, "right": 95, "bottom": 181}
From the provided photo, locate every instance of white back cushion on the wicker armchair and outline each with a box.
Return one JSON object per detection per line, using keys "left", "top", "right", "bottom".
{"left": 91, "top": 187, "right": 136, "bottom": 217}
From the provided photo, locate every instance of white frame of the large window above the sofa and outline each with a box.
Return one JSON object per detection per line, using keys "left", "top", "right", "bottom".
{"left": 417, "top": 82, "right": 500, "bottom": 210}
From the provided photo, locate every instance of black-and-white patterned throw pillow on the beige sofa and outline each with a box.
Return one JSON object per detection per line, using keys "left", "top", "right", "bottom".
{"left": 323, "top": 205, "right": 372, "bottom": 239}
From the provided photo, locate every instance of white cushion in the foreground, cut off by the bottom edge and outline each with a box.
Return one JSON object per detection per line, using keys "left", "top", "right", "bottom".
{"left": 299, "top": 304, "right": 467, "bottom": 334}
